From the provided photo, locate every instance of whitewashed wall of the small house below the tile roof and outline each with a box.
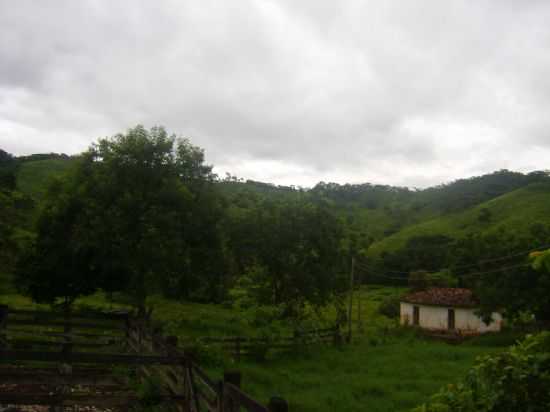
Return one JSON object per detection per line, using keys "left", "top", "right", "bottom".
{"left": 400, "top": 302, "right": 502, "bottom": 333}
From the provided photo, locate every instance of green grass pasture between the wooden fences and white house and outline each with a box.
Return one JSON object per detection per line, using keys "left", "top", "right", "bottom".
{"left": 0, "top": 287, "right": 517, "bottom": 412}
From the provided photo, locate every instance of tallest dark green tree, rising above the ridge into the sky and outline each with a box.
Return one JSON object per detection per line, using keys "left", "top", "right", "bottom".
{"left": 19, "top": 126, "right": 224, "bottom": 309}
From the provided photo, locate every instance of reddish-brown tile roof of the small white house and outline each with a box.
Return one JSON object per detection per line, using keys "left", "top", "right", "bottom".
{"left": 401, "top": 288, "right": 479, "bottom": 308}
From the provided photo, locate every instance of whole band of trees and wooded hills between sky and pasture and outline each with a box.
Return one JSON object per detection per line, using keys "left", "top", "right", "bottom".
{"left": 0, "top": 126, "right": 550, "bottom": 319}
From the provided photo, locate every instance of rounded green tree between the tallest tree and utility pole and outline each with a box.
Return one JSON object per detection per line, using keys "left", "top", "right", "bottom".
{"left": 230, "top": 199, "right": 346, "bottom": 316}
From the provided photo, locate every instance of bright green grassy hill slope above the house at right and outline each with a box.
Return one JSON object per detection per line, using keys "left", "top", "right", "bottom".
{"left": 368, "top": 182, "right": 550, "bottom": 257}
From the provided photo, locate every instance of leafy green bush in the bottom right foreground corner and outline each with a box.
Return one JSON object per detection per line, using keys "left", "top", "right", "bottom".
{"left": 414, "top": 332, "right": 550, "bottom": 412}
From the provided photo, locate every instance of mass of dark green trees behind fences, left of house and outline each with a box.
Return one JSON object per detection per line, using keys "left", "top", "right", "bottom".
{"left": 4, "top": 126, "right": 350, "bottom": 316}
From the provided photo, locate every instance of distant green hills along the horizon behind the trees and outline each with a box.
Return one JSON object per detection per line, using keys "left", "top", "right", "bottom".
{"left": 10, "top": 154, "right": 550, "bottom": 266}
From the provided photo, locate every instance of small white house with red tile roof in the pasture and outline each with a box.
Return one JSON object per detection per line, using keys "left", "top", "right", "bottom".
{"left": 400, "top": 288, "right": 502, "bottom": 334}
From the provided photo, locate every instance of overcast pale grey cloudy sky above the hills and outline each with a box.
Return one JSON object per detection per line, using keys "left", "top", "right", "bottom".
{"left": 0, "top": 0, "right": 550, "bottom": 187}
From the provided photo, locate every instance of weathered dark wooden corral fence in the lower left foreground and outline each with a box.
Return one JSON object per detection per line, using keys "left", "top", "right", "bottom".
{"left": 0, "top": 306, "right": 288, "bottom": 412}
